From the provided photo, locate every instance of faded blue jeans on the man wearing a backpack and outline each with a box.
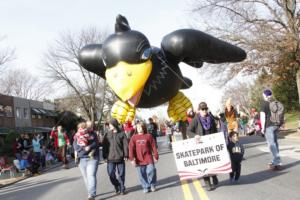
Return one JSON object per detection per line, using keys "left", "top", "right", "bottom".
{"left": 265, "top": 126, "right": 281, "bottom": 165}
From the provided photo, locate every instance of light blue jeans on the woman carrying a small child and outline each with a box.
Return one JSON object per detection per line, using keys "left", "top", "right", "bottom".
{"left": 79, "top": 157, "right": 99, "bottom": 197}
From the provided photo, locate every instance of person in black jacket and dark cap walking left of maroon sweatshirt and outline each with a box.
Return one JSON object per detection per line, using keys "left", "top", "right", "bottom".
{"left": 102, "top": 119, "right": 128, "bottom": 194}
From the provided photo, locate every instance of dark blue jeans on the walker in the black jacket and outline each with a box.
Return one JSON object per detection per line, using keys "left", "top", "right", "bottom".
{"left": 107, "top": 162, "right": 125, "bottom": 192}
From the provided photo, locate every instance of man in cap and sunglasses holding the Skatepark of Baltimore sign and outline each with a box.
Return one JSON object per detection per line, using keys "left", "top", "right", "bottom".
{"left": 187, "top": 102, "right": 219, "bottom": 191}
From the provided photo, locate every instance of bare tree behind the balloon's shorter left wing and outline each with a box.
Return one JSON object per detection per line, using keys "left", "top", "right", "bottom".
{"left": 43, "top": 28, "right": 112, "bottom": 121}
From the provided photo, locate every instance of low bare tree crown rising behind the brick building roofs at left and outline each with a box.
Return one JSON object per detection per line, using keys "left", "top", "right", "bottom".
{"left": 0, "top": 69, "right": 51, "bottom": 100}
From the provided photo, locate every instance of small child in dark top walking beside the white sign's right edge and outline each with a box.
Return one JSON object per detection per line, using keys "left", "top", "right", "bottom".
{"left": 227, "top": 131, "right": 244, "bottom": 183}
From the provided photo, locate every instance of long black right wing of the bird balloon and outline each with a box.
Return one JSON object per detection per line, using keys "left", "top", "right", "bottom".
{"left": 161, "top": 29, "right": 247, "bottom": 68}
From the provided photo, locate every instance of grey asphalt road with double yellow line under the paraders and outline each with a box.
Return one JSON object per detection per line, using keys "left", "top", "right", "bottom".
{"left": 0, "top": 136, "right": 300, "bottom": 200}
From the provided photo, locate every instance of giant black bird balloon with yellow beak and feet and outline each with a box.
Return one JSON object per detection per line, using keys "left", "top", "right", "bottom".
{"left": 79, "top": 15, "right": 246, "bottom": 123}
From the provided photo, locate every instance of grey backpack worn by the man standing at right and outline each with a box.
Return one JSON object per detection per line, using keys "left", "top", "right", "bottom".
{"left": 269, "top": 101, "right": 284, "bottom": 126}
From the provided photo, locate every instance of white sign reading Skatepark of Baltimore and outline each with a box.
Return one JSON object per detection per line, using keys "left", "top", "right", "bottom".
{"left": 172, "top": 132, "right": 232, "bottom": 180}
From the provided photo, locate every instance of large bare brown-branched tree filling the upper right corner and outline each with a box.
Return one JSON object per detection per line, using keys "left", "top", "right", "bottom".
{"left": 193, "top": 0, "right": 300, "bottom": 103}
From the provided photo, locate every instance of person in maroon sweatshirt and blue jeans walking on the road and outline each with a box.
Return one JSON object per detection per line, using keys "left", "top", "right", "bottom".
{"left": 129, "top": 122, "right": 158, "bottom": 193}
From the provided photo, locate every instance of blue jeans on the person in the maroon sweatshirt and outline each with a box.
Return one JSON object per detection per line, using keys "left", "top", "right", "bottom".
{"left": 136, "top": 164, "right": 156, "bottom": 189}
